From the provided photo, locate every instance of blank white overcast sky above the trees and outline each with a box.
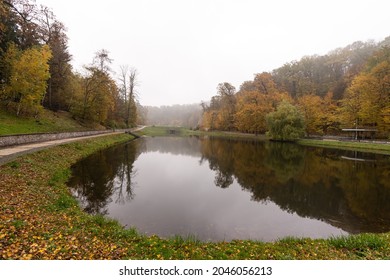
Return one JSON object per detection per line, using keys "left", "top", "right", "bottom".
{"left": 37, "top": 0, "right": 390, "bottom": 105}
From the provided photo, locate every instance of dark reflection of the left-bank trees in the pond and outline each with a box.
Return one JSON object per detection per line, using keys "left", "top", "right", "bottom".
{"left": 68, "top": 143, "right": 140, "bottom": 215}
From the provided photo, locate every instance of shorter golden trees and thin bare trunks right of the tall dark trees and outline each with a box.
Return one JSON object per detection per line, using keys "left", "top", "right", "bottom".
{"left": 71, "top": 49, "right": 143, "bottom": 127}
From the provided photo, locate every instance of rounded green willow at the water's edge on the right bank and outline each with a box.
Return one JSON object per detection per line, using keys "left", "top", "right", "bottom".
{"left": 267, "top": 101, "right": 305, "bottom": 141}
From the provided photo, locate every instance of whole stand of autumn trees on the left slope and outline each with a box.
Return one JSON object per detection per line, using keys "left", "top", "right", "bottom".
{"left": 0, "top": 0, "right": 138, "bottom": 127}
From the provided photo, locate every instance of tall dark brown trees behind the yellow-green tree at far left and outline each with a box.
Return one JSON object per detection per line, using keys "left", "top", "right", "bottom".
{"left": 0, "top": 0, "right": 71, "bottom": 115}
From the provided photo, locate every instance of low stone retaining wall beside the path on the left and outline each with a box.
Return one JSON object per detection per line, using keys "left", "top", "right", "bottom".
{"left": 0, "top": 130, "right": 112, "bottom": 147}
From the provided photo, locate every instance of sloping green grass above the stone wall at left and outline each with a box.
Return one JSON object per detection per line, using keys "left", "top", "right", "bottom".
{"left": 0, "top": 107, "right": 88, "bottom": 135}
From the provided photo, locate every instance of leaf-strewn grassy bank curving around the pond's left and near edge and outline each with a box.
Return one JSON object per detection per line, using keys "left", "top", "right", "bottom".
{"left": 0, "top": 130, "right": 390, "bottom": 259}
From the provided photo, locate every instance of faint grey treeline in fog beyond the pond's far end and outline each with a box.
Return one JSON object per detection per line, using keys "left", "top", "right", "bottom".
{"left": 144, "top": 104, "right": 202, "bottom": 129}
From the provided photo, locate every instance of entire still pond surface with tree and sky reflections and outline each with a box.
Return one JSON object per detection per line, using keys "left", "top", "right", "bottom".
{"left": 69, "top": 137, "right": 390, "bottom": 241}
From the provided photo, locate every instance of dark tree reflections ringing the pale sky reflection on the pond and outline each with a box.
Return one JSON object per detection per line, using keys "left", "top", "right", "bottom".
{"left": 69, "top": 137, "right": 390, "bottom": 238}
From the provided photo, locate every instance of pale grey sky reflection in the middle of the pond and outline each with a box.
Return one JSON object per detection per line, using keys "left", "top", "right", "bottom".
{"left": 108, "top": 152, "right": 346, "bottom": 241}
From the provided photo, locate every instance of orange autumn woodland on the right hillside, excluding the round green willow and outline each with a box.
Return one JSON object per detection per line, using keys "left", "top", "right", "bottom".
{"left": 201, "top": 37, "right": 390, "bottom": 138}
